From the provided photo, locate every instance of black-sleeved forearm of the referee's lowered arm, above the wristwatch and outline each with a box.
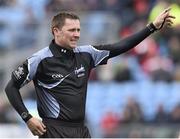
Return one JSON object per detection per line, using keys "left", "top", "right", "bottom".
{"left": 5, "top": 79, "right": 31, "bottom": 120}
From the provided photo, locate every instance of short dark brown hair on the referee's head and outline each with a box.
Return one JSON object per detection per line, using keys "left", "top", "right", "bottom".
{"left": 51, "top": 12, "right": 80, "bottom": 35}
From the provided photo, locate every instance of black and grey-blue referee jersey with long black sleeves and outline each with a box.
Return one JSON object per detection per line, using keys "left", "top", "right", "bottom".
{"left": 6, "top": 27, "right": 152, "bottom": 122}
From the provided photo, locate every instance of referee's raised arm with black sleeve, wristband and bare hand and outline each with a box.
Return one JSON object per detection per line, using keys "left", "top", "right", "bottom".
{"left": 94, "top": 8, "right": 175, "bottom": 58}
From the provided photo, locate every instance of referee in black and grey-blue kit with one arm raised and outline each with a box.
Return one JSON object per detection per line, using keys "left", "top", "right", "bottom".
{"left": 5, "top": 9, "right": 174, "bottom": 138}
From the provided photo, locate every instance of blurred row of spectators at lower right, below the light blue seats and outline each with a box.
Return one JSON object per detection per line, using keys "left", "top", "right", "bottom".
{"left": 100, "top": 97, "right": 180, "bottom": 138}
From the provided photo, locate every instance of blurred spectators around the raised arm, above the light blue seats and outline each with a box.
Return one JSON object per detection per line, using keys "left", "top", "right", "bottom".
{"left": 88, "top": 0, "right": 180, "bottom": 82}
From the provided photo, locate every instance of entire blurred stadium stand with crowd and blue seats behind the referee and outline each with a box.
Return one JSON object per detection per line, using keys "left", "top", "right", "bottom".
{"left": 0, "top": 0, "right": 180, "bottom": 138}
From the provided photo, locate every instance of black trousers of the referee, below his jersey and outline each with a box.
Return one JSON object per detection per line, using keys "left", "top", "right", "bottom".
{"left": 39, "top": 119, "right": 91, "bottom": 138}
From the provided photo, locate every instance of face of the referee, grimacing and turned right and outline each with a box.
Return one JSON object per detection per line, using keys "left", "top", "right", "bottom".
{"left": 54, "top": 19, "right": 80, "bottom": 49}
